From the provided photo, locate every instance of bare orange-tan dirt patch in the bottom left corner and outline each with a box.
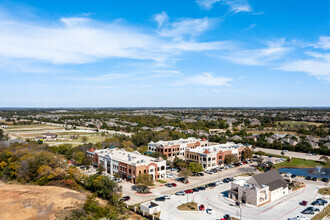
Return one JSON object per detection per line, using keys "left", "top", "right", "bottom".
{"left": 0, "top": 182, "right": 87, "bottom": 220}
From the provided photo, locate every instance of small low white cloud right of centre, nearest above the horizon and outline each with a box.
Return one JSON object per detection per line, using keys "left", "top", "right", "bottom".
{"left": 176, "top": 73, "right": 232, "bottom": 87}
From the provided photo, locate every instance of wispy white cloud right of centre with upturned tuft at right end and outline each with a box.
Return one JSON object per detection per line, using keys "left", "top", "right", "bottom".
{"left": 220, "top": 39, "right": 290, "bottom": 66}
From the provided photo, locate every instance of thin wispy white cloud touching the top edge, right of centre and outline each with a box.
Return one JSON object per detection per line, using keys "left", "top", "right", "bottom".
{"left": 196, "top": 0, "right": 252, "bottom": 14}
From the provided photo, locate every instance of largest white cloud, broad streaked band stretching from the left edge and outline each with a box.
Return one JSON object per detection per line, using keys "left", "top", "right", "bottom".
{"left": 0, "top": 17, "right": 227, "bottom": 64}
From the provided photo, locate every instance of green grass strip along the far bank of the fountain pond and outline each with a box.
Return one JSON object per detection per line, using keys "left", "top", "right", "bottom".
{"left": 274, "top": 158, "right": 330, "bottom": 169}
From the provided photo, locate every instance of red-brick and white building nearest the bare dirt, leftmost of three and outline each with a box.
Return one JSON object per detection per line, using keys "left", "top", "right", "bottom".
{"left": 87, "top": 148, "right": 166, "bottom": 183}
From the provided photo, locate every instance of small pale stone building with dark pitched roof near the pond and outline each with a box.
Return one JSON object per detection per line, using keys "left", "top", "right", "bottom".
{"left": 228, "top": 170, "right": 289, "bottom": 206}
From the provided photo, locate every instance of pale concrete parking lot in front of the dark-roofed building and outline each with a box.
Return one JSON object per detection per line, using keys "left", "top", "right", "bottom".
{"left": 157, "top": 177, "right": 329, "bottom": 220}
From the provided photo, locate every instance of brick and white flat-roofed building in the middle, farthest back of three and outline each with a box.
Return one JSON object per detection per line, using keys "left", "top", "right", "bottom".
{"left": 148, "top": 137, "right": 209, "bottom": 158}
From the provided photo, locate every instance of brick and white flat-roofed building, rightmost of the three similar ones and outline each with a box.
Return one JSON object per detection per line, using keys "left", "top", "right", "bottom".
{"left": 185, "top": 142, "right": 251, "bottom": 169}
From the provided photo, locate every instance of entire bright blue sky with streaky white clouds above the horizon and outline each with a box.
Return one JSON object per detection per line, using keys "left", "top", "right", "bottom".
{"left": 0, "top": 0, "right": 330, "bottom": 107}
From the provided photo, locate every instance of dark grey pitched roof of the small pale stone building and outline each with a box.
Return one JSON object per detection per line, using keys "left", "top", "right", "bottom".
{"left": 251, "top": 170, "right": 288, "bottom": 191}
